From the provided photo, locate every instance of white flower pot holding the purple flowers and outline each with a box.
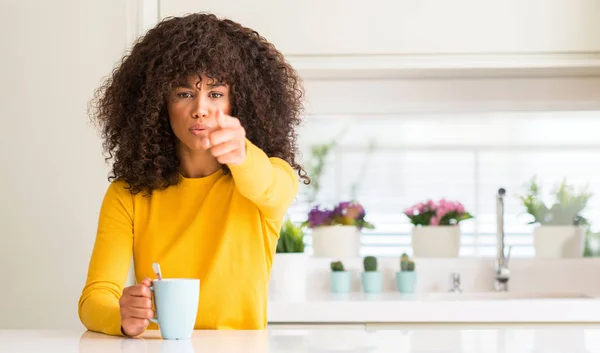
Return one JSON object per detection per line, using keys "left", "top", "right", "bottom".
{"left": 312, "top": 225, "right": 360, "bottom": 259}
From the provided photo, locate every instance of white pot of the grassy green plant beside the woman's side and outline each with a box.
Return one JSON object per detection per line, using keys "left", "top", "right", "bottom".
{"left": 269, "top": 253, "right": 308, "bottom": 300}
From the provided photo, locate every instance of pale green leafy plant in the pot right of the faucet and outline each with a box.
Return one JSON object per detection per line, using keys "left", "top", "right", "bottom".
{"left": 519, "top": 176, "right": 592, "bottom": 226}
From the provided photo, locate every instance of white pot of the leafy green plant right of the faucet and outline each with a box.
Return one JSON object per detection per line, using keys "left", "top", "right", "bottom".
{"left": 533, "top": 226, "right": 586, "bottom": 259}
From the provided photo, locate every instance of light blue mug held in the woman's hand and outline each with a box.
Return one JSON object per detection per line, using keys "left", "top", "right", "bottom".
{"left": 150, "top": 278, "right": 200, "bottom": 340}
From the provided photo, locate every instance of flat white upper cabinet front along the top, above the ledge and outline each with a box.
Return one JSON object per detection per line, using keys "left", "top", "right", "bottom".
{"left": 159, "top": 0, "right": 600, "bottom": 56}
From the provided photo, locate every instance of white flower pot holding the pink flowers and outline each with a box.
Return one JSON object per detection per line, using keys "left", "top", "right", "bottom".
{"left": 412, "top": 226, "right": 460, "bottom": 257}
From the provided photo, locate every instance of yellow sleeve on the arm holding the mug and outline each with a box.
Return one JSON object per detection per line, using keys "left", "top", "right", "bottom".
{"left": 78, "top": 182, "right": 133, "bottom": 336}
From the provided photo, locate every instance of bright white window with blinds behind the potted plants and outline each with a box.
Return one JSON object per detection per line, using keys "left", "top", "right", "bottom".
{"left": 289, "top": 111, "right": 600, "bottom": 257}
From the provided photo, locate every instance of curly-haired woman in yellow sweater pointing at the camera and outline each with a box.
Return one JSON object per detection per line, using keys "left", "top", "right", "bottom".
{"left": 79, "top": 14, "right": 310, "bottom": 336}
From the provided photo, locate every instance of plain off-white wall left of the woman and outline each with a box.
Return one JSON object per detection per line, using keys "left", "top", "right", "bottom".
{"left": 0, "top": 0, "right": 132, "bottom": 329}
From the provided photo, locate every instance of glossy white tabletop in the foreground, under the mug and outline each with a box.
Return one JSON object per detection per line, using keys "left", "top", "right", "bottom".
{"left": 0, "top": 325, "right": 600, "bottom": 353}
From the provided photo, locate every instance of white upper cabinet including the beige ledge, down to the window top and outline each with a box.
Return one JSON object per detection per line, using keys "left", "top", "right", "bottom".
{"left": 156, "top": 0, "right": 600, "bottom": 114}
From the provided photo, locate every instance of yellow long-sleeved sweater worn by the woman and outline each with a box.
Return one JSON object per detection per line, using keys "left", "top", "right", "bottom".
{"left": 79, "top": 140, "right": 298, "bottom": 335}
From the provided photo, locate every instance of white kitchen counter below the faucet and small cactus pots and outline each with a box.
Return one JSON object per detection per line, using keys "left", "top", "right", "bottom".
{"left": 268, "top": 292, "right": 600, "bottom": 323}
